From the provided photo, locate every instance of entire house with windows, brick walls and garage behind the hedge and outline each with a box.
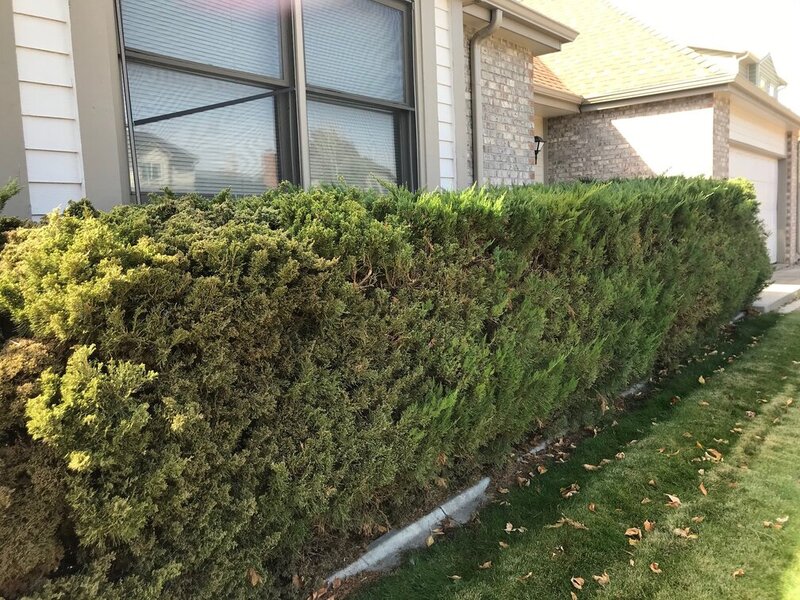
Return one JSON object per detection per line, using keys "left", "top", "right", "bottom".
{"left": 0, "top": 0, "right": 800, "bottom": 261}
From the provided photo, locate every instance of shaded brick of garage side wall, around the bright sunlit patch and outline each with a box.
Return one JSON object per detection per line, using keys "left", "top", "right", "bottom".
{"left": 545, "top": 94, "right": 712, "bottom": 183}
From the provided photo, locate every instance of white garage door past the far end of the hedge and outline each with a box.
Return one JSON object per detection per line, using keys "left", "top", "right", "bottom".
{"left": 730, "top": 148, "right": 778, "bottom": 262}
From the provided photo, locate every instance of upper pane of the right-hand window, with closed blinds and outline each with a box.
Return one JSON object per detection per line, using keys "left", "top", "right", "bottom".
{"left": 303, "top": 0, "right": 405, "bottom": 102}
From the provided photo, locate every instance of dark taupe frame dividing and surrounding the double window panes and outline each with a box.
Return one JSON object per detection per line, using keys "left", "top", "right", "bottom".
{"left": 115, "top": 0, "right": 419, "bottom": 203}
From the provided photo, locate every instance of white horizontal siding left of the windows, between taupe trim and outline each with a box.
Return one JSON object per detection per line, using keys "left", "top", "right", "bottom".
{"left": 13, "top": 0, "right": 85, "bottom": 217}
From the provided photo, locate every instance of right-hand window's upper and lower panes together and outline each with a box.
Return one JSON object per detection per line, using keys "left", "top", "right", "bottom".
{"left": 303, "top": 0, "right": 413, "bottom": 188}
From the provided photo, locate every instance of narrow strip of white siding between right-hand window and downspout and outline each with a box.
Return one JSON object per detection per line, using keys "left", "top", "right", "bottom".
{"left": 435, "top": 0, "right": 456, "bottom": 190}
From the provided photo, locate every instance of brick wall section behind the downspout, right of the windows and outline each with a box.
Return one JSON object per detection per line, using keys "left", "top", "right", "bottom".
{"left": 464, "top": 27, "right": 534, "bottom": 185}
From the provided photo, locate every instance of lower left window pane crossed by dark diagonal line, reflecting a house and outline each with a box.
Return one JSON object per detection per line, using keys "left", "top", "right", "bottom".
{"left": 128, "top": 63, "right": 278, "bottom": 194}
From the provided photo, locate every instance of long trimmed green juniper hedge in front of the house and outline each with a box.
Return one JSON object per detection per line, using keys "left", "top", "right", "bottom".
{"left": 0, "top": 178, "right": 769, "bottom": 599}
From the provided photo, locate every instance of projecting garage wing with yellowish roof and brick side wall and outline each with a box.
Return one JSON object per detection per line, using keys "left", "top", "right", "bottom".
{"left": 531, "top": 0, "right": 800, "bottom": 263}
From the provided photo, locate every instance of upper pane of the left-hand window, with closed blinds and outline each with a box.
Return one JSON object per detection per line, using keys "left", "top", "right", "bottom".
{"left": 122, "top": 0, "right": 281, "bottom": 77}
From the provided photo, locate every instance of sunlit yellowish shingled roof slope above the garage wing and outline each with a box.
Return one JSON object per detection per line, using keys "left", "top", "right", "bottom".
{"left": 524, "top": 0, "right": 730, "bottom": 102}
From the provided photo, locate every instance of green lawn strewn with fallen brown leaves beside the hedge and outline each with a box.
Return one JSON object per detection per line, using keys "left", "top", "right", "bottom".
{"left": 356, "top": 314, "right": 800, "bottom": 600}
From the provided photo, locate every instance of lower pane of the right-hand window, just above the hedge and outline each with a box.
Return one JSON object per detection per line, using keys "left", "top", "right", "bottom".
{"left": 308, "top": 100, "right": 397, "bottom": 189}
